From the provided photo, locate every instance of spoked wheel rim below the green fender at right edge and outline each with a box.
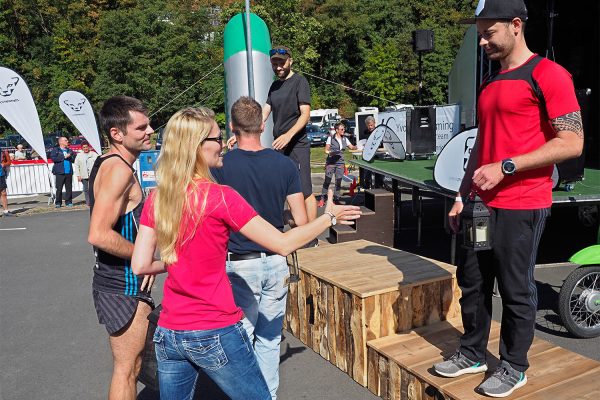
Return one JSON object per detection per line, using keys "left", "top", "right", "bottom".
{"left": 569, "top": 272, "right": 600, "bottom": 329}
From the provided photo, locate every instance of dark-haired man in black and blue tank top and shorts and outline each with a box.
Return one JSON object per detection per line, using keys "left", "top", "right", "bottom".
{"left": 88, "top": 96, "right": 154, "bottom": 400}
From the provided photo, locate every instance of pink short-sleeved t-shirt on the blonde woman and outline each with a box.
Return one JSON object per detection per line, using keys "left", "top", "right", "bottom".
{"left": 140, "top": 181, "right": 257, "bottom": 330}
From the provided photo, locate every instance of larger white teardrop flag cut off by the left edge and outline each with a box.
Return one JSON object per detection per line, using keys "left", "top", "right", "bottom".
{"left": 0, "top": 67, "right": 48, "bottom": 162}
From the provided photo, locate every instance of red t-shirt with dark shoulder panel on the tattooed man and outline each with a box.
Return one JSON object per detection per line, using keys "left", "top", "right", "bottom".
{"left": 477, "top": 55, "right": 580, "bottom": 210}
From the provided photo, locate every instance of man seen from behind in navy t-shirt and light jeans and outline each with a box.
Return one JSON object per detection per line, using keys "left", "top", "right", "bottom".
{"left": 211, "top": 97, "right": 307, "bottom": 399}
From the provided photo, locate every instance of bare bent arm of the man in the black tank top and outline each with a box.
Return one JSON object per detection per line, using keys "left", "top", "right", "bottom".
{"left": 88, "top": 160, "right": 133, "bottom": 259}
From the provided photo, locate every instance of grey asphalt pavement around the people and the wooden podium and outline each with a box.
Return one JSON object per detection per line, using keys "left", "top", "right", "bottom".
{"left": 0, "top": 176, "right": 600, "bottom": 400}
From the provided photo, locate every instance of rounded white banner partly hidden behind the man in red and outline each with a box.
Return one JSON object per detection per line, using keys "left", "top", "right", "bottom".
{"left": 433, "top": 128, "right": 477, "bottom": 192}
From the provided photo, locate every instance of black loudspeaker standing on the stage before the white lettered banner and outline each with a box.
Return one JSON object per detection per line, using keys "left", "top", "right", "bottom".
{"left": 406, "top": 107, "right": 436, "bottom": 159}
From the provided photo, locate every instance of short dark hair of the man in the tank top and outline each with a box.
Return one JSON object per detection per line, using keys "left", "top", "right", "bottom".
{"left": 100, "top": 96, "right": 148, "bottom": 143}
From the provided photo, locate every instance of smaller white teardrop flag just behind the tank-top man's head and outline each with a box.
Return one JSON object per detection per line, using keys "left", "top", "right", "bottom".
{"left": 58, "top": 90, "right": 102, "bottom": 154}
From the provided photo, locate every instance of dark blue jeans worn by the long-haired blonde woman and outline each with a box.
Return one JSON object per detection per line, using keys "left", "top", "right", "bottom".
{"left": 154, "top": 322, "right": 271, "bottom": 400}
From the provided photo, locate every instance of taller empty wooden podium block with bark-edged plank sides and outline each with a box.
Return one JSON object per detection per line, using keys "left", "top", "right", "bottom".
{"left": 285, "top": 240, "right": 460, "bottom": 386}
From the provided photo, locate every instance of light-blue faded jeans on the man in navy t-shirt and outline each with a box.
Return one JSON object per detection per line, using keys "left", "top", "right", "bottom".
{"left": 227, "top": 254, "right": 290, "bottom": 399}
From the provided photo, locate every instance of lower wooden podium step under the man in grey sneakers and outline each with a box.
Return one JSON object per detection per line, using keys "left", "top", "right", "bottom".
{"left": 367, "top": 318, "right": 600, "bottom": 400}
